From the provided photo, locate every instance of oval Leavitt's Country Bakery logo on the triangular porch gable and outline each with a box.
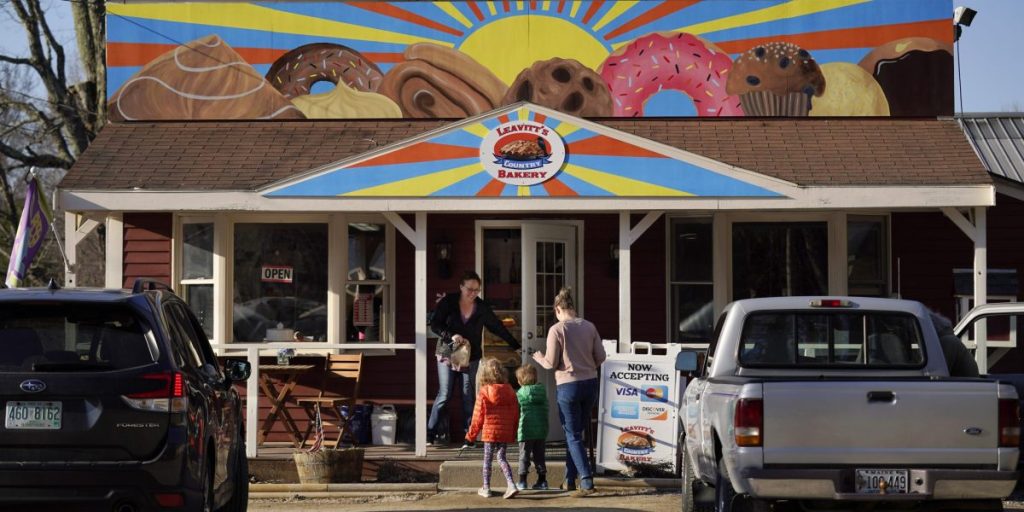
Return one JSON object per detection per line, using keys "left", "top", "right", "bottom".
{"left": 480, "top": 121, "right": 565, "bottom": 185}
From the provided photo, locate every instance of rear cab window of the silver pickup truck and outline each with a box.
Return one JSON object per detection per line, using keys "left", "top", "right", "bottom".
{"left": 739, "top": 311, "right": 925, "bottom": 368}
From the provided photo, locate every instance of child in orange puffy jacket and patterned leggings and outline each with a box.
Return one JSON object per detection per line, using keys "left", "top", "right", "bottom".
{"left": 466, "top": 357, "right": 519, "bottom": 500}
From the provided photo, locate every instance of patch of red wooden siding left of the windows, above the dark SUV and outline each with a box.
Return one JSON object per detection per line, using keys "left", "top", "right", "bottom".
{"left": 123, "top": 213, "right": 173, "bottom": 288}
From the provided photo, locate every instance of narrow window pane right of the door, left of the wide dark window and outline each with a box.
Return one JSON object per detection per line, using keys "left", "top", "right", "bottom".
{"left": 669, "top": 218, "right": 715, "bottom": 343}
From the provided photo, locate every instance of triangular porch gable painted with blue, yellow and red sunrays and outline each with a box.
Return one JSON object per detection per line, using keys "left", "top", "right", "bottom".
{"left": 263, "top": 104, "right": 782, "bottom": 199}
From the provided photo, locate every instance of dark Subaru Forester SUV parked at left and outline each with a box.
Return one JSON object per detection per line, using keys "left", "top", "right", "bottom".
{"left": 0, "top": 282, "right": 250, "bottom": 512}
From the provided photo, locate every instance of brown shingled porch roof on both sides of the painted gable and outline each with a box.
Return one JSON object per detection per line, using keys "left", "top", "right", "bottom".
{"left": 60, "top": 118, "right": 992, "bottom": 191}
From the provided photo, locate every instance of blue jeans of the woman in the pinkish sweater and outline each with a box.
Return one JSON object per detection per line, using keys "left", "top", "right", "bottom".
{"left": 555, "top": 378, "right": 598, "bottom": 486}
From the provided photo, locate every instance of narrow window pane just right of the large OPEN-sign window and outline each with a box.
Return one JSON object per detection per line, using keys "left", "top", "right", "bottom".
{"left": 345, "top": 222, "right": 392, "bottom": 343}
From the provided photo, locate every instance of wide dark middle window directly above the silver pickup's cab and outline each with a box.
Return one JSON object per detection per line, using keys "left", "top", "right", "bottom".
{"left": 732, "top": 222, "right": 828, "bottom": 300}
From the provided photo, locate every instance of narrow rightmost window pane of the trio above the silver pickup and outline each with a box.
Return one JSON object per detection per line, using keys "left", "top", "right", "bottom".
{"left": 846, "top": 216, "right": 889, "bottom": 297}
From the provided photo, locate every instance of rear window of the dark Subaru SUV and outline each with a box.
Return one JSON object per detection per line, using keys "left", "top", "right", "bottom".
{"left": 0, "top": 302, "right": 157, "bottom": 373}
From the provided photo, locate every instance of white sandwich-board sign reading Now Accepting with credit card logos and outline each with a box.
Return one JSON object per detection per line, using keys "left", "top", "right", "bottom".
{"left": 597, "top": 353, "right": 679, "bottom": 470}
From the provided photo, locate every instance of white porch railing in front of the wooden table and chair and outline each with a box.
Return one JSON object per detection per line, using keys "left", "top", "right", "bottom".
{"left": 211, "top": 341, "right": 417, "bottom": 459}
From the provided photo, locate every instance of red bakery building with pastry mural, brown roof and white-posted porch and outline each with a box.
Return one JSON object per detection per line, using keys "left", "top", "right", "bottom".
{"left": 59, "top": 0, "right": 1021, "bottom": 455}
